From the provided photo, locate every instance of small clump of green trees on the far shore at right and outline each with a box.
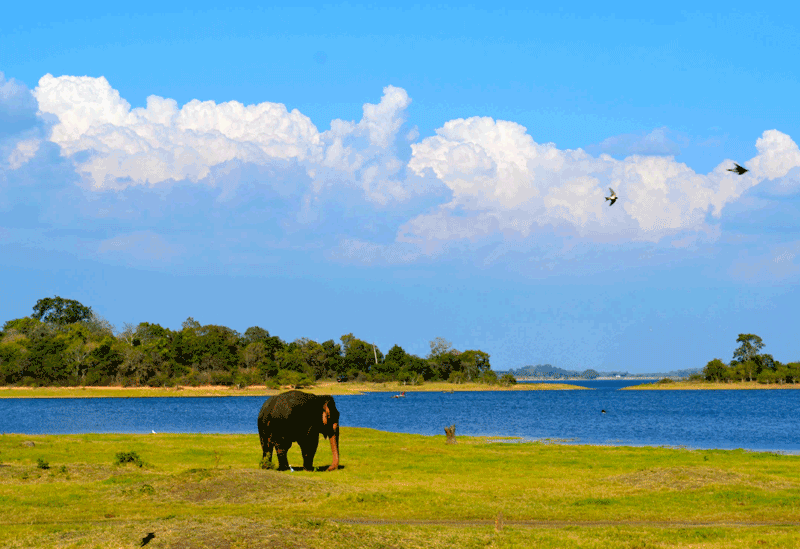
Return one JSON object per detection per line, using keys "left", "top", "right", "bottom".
{"left": 697, "top": 334, "right": 800, "bottom": 384}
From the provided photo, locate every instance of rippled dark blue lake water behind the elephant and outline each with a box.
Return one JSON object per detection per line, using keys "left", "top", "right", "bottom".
{"left": 0, "top": 381, "right": 800, "bottom": 453}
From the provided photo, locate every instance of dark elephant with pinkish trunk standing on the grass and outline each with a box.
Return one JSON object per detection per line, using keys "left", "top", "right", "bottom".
{"left": 258, "top": 391, "right": 339, "bottom": 471}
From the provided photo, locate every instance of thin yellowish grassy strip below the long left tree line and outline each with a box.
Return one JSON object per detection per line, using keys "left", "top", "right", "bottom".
{"left": 0, "top": 381, "right": 586, "bottom": 398}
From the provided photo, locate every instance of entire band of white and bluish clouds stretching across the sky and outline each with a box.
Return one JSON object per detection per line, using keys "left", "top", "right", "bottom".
{"left": 0, "top": 74, "right": 800, "bottom": 274}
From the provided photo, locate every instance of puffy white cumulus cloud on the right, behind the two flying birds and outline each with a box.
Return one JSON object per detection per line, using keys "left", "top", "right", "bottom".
{"left": 406, "top": 117, "right": 800, "bottom": 242}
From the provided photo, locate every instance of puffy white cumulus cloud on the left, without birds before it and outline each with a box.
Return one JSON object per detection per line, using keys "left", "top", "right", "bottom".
{"left": 31, "top": 74, "right": 418, "bottom": 205}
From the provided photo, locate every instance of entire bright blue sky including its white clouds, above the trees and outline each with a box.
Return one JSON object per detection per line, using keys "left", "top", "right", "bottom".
{"left": 0, "top": 2, "right": 800, "bottom": 372}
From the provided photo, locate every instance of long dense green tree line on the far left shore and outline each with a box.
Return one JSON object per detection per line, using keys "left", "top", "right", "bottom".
{"left": 0, "top": 296, "right": 515, "bottom": 387}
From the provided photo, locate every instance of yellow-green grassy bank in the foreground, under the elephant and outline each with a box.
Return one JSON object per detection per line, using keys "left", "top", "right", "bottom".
{"left": 0, "top": 427, "right": 800, "bottom": 548}
